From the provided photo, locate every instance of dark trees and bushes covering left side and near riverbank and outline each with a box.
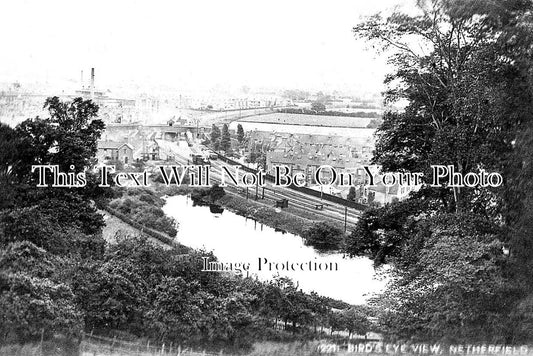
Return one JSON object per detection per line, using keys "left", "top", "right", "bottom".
{"left": 0, "top": 98, "right": 369, "bottom": 354}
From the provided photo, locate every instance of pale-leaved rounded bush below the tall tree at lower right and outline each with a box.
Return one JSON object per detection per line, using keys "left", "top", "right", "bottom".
{"left": 377, "top": 213, "right": 518, "bottom": 342}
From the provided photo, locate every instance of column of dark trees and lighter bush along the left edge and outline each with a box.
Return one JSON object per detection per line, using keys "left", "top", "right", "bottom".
{"left": 0, "top": 97, "right": 105, "bottom": 342}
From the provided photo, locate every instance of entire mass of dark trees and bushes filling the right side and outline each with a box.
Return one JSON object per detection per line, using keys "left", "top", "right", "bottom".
{"left": 346, "top": 0, "right": 533, "bottom": 343}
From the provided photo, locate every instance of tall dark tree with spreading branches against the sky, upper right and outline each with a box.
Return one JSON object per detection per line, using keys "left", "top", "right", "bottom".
{"left": 354, "top": 1, "right": 531, "bottom": 211}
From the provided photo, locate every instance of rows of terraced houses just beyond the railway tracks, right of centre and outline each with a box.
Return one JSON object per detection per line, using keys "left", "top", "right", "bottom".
{"left": 242, "top": 131, "right": 419, "bottom": 205}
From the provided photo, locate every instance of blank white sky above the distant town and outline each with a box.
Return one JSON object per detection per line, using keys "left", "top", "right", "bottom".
{"left": 0, "top": 0, "right": 412, "bottom": 96}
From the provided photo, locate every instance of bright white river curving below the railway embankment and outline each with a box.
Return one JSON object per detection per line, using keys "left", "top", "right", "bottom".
{"left": 163, "top": 196, "right": 385, "bottom": 304}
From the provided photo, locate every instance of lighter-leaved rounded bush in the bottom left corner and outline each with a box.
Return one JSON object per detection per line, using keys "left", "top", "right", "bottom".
{"left": 0, "top": 241, "right": 83, "bottom": 343}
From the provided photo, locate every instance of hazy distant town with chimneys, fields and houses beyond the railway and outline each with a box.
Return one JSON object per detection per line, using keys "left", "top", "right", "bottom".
{"left": 0, "top": 68, "right": 417, "bottom": 206}
